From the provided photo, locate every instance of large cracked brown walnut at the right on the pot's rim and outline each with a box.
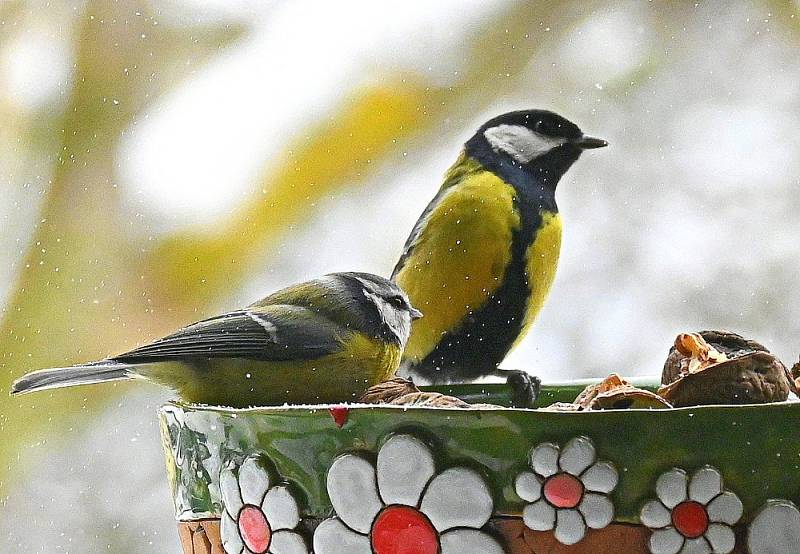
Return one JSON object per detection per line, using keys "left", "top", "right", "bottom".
{"left": 658, "top": 331, "right": 795, "bottom": 407}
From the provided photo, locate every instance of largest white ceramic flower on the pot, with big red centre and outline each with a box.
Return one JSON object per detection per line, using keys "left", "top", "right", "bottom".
{"left": 314, "top": 435, "right": 503, "bottom": 554}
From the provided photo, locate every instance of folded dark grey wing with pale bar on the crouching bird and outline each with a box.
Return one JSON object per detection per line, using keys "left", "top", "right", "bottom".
{"left": 113, "top": 305, "right": 347, "bottom": 363}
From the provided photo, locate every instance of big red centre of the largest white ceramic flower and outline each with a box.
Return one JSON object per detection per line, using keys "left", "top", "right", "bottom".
{"left": 370, "top": 506, "right": 439, "bottom": 554}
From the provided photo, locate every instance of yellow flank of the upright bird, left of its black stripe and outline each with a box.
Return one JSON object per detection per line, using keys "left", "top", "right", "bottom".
{"left": 392, "top": 171, "right": 520, "bottom": 359}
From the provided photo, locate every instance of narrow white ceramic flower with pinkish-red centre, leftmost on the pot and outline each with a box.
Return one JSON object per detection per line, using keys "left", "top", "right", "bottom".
{"left": 219, "top": 456, "right": 308, "bottom": 554}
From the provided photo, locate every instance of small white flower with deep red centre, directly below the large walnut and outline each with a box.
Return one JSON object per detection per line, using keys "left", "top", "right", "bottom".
{"left": 639, "top": 466, "right": 743, "bottom": 554}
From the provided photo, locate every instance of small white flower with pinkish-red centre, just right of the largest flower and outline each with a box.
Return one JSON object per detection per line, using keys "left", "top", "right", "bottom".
{"left": 514, "top": 437, "right": 619, "bottom": 544}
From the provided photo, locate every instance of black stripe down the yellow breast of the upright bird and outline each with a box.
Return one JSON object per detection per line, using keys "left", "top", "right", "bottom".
{"left": 411, "top": 183, "right": 557, "bottom": 382}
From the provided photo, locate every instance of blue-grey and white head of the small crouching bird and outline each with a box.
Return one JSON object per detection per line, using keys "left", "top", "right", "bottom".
{"left": 328, "top": 272, "right": 422, "bottom": 348}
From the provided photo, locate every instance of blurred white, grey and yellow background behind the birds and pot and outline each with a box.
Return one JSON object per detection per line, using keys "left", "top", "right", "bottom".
{"left": 0, "top": 0, "right": 800, "bottom": 553}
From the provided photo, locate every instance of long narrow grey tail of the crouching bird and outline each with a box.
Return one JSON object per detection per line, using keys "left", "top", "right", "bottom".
{"left": 11, "top": 360, "right": 135, "bottom": 394}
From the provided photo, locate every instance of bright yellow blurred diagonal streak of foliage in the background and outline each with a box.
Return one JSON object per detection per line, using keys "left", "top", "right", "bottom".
{"left": 146, "top": 80, "right": 425, "bottom": 306}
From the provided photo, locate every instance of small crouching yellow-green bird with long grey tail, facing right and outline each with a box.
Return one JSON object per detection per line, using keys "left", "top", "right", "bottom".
{"left": 12, "top": 273, "right": 422, "bottom": 407}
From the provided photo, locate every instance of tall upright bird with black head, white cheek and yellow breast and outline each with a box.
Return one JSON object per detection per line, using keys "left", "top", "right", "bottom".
{"left": 392, "top": 110, "right": 607, "bottom": 404}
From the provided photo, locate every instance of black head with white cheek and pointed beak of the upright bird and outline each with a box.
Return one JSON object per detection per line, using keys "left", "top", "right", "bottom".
{"left": 465, "top": 110, "right": 608, "bottom": 188}
